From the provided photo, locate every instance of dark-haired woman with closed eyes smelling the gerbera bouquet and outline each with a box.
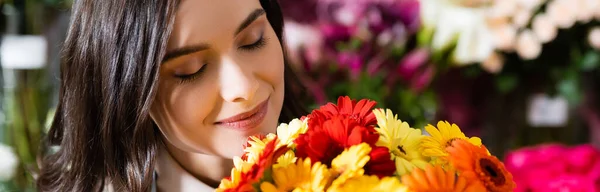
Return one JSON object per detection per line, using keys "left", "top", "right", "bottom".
{"left": 38, "top": 0, "right": 304, "bottom": 191}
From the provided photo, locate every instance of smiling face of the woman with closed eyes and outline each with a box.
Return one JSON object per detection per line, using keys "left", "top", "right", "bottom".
{"left": 150, "top": 0, "right": 284, "bottom": 158}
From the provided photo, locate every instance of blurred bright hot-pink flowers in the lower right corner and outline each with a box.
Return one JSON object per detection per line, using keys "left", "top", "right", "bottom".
{"left": 505, "top": 144, "right": 600, "bottom": 192}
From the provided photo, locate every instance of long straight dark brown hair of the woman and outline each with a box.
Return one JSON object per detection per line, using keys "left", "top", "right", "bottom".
{"left": 37, "top": 0, "right": 306, "bottom": 192}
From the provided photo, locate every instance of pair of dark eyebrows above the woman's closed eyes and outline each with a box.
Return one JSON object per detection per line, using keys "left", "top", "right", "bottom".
{"left": 162, "top": 9, "right": 265, "bottom": 63}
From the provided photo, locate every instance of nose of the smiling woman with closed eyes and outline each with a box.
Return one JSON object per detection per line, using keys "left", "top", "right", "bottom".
{"left": 219, "top": 58, "right": 259, "bottom": 102}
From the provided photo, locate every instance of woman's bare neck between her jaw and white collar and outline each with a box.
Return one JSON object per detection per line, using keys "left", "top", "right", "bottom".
{"left": 159, "top": 141, "right": 233, "bottom": 188}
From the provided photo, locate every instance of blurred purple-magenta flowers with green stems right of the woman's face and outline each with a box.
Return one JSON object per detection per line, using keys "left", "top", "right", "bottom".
{"left": 281, "top": 0, "right": 437, "bottom": 126}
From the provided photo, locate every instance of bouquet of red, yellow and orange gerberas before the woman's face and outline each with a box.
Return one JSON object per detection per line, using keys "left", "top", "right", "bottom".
{"left": 217, "top": 97, "right": 515, "bottom": 192}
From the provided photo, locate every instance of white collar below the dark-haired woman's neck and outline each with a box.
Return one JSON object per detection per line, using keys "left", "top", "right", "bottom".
{"left": 155, "top": 147, "right": 215, "bottom": 192}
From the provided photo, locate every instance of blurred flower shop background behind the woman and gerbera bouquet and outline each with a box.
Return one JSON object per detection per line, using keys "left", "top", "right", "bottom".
{"left": 0, "top": 0, "right": 600, "bottom": 191}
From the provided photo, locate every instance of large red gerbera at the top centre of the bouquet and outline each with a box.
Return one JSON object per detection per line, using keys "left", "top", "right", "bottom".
{"left": 295, "top": 116, "right": 379, "bottom": 165}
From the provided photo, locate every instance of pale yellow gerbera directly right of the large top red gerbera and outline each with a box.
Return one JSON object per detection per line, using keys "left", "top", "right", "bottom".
{"left": 373, "top": 109, "right": 428, "bottom": 175}
